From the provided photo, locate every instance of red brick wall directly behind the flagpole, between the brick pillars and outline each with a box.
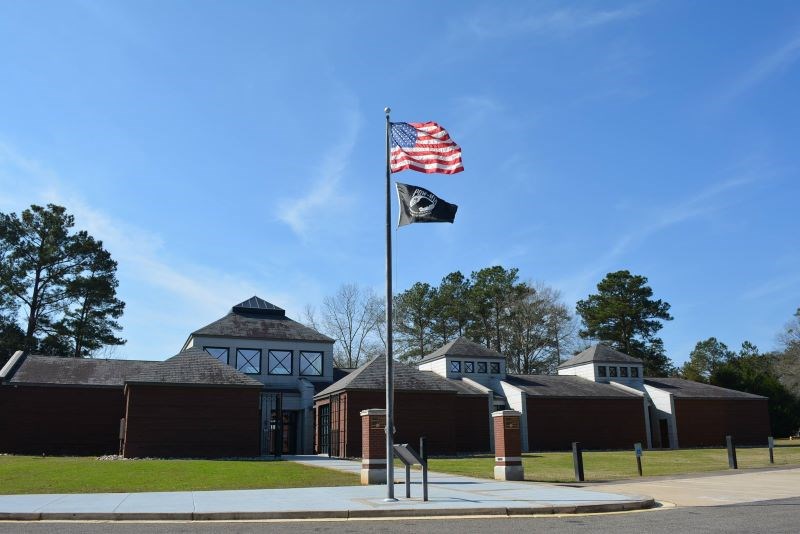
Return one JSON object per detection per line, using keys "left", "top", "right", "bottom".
{"left": 318, "top": 390, "right": 489, "bottom": 458}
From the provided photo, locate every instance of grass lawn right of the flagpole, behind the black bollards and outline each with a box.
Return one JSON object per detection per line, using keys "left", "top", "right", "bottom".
{"left": 428, "top": 440, "right": 800, "bottom": 482}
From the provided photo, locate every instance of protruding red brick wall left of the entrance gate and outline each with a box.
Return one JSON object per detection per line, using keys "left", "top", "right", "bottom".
{"left": 125, "top": 385, "right": 261, "bottom": 458}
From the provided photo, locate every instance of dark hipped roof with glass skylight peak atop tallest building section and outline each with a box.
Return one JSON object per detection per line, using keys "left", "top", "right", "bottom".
{"left": 192, "top": 297, "right": 334, "bottom": 343}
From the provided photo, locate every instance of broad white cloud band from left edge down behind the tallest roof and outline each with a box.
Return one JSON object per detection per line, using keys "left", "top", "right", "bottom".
{"left": 0, "top": 142, "right": 304, "bottom": 358}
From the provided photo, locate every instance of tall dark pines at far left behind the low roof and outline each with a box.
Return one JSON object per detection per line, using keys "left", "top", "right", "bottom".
{"left": 0, "top": 204, "right": 125, "bottom": 356}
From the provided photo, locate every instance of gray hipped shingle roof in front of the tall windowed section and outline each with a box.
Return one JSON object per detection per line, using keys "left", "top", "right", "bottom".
{"left": 128, "top": 348, "right": 263, "bottom": 388}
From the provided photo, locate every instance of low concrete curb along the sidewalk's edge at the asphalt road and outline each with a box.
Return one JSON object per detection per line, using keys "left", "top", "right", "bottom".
{"left": 0, "top": 497, "right": 655, "bottom": 521}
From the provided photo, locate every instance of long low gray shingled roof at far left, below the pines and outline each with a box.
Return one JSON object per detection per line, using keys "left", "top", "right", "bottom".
{"left": 5, "top": 354, "right": 162, "bottom": 387}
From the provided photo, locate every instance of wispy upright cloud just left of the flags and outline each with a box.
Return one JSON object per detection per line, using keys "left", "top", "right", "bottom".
{"left": 278, "top": 99, "right": 363, "bottom": 239}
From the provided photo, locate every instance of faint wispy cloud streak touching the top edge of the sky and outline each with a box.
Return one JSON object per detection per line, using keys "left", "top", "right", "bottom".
{"left": 454, "top": 4, "right": 642, "bottom": 39}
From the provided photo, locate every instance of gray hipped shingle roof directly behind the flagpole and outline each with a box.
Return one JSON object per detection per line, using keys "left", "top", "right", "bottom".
{"left": 316, "top": 355, "right": 482, "bottom": 397}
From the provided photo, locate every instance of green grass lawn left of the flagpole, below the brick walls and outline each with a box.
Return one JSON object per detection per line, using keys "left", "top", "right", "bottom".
{"left": 0, "top": 456, "right": 359, "bottom": 495}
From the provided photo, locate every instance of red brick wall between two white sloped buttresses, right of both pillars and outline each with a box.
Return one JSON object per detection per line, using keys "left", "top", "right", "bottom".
{"left": 527, "top": 397, "right": 647, "bottom": 451}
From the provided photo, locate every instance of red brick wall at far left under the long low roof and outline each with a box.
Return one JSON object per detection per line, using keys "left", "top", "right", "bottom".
{"left": 0, "top": 386, "right": 125, "bottom": 455}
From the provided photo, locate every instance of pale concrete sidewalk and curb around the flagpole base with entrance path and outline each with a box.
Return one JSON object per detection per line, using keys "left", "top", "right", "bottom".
{"left": 0, "top": 456, "right": 654, "bottom": 520}
